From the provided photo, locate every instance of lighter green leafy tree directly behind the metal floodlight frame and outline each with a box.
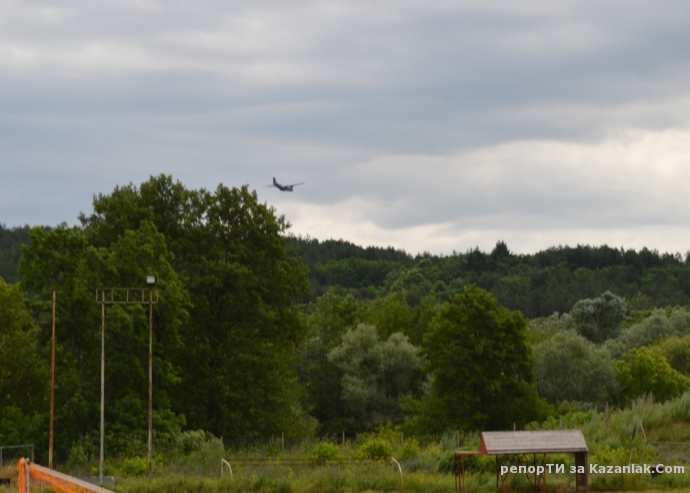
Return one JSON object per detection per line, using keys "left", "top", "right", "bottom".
{"left": 20, "top": 222, "right": 188, "bottom": 458}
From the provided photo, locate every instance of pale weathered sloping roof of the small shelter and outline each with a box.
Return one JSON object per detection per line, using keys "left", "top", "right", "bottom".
{"left": 479, "top": 430, "right": 588, "bottom": 455}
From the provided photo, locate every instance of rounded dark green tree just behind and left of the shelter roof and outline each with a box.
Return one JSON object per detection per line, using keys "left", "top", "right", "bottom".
{"left": 418, "top": 286, "right": 543, "bottom": 431}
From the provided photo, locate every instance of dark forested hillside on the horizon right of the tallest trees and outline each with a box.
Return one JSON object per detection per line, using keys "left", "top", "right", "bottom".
{"left": 288, "top": 237, "right": 690, "bottom": 318}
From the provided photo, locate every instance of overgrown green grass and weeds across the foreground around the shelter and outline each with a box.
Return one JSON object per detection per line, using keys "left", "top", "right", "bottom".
{"left": 6, "top": 393, "right": 690, "bottom": 493}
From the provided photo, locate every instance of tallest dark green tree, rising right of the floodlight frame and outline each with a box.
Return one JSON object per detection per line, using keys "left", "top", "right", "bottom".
{"left": 80, "top": 175, "right": 307, "bottom": 439}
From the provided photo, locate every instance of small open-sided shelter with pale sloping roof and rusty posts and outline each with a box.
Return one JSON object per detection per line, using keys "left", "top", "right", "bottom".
{"left": 455, "top": 430, "right": 589, "bottom": 493}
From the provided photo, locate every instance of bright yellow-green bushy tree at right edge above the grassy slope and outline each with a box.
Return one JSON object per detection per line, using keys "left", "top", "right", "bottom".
{"left": 614, "top": 347, "right": 690, "bottom": 404}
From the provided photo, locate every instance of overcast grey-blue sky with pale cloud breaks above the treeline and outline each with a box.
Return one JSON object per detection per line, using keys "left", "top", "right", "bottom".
{"left": 0, "top": 0, "right": 690, "bottom": 254}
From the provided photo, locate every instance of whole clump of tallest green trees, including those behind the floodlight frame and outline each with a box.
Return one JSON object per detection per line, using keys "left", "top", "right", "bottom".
{"left": 20, "top": 175, "right": 307, "bottom": 458}
